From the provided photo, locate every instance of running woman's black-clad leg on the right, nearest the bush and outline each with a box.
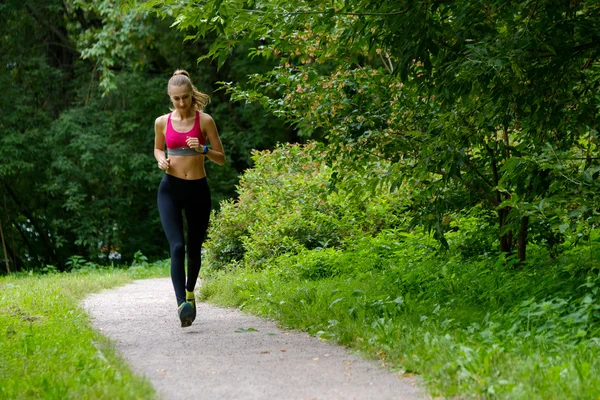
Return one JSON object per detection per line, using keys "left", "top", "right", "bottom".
{"left": 185, "top": 178, "right": 211, "bottom": 292}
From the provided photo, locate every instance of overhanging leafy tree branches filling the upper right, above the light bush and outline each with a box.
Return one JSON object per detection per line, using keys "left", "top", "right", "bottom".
{"left": 143, "top": 0, "right": 600, "bottom": 260}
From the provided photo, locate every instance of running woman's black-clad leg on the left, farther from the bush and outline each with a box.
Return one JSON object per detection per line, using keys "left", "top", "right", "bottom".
{"left": 158, "top": 175, "right": 185, "bottom": 305}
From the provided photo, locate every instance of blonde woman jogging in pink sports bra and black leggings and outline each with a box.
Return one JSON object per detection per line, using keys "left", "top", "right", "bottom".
{"left": 154, "top": 70, "right": 225, "bottom": 327}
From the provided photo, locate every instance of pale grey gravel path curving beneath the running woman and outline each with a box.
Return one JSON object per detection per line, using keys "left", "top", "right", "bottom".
{"left": 83, "top": 278, "right": 427, "bottom": 400}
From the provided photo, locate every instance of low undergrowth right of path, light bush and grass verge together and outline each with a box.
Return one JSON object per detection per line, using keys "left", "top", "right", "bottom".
{"left": 201, "top": 143, "right": 600, "bottom": 399}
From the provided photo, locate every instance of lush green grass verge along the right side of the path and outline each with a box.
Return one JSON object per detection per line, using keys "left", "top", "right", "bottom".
{"left": 201, "top": 233, "right": 600, "bottom": 399}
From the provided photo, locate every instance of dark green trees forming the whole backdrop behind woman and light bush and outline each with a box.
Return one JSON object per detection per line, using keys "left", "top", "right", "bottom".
{"left": 0, "top": 1, "right": 600, "bottom": 270}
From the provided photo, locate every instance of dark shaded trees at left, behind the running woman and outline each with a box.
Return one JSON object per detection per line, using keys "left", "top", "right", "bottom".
{"left": 0, "top": 0, "right": 297, "bottom": 271}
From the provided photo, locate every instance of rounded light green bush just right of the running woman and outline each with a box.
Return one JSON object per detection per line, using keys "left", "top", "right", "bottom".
{"left": 206, "top": 142, "right": 403, "bottom": 269}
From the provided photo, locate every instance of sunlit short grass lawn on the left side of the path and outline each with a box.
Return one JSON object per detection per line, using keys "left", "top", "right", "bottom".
{"left": 0, "top": 263, "right": 168, "bottom": 399}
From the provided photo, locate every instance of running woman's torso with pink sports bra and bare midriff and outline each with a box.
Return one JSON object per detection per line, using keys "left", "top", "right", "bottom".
{"left": 163, "top": 111, "right": 206, "bottom": 180}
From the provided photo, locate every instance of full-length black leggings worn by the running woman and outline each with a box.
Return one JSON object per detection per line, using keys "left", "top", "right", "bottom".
{"left": 158, "top": 174, "right": 211, "bottom": 305}
